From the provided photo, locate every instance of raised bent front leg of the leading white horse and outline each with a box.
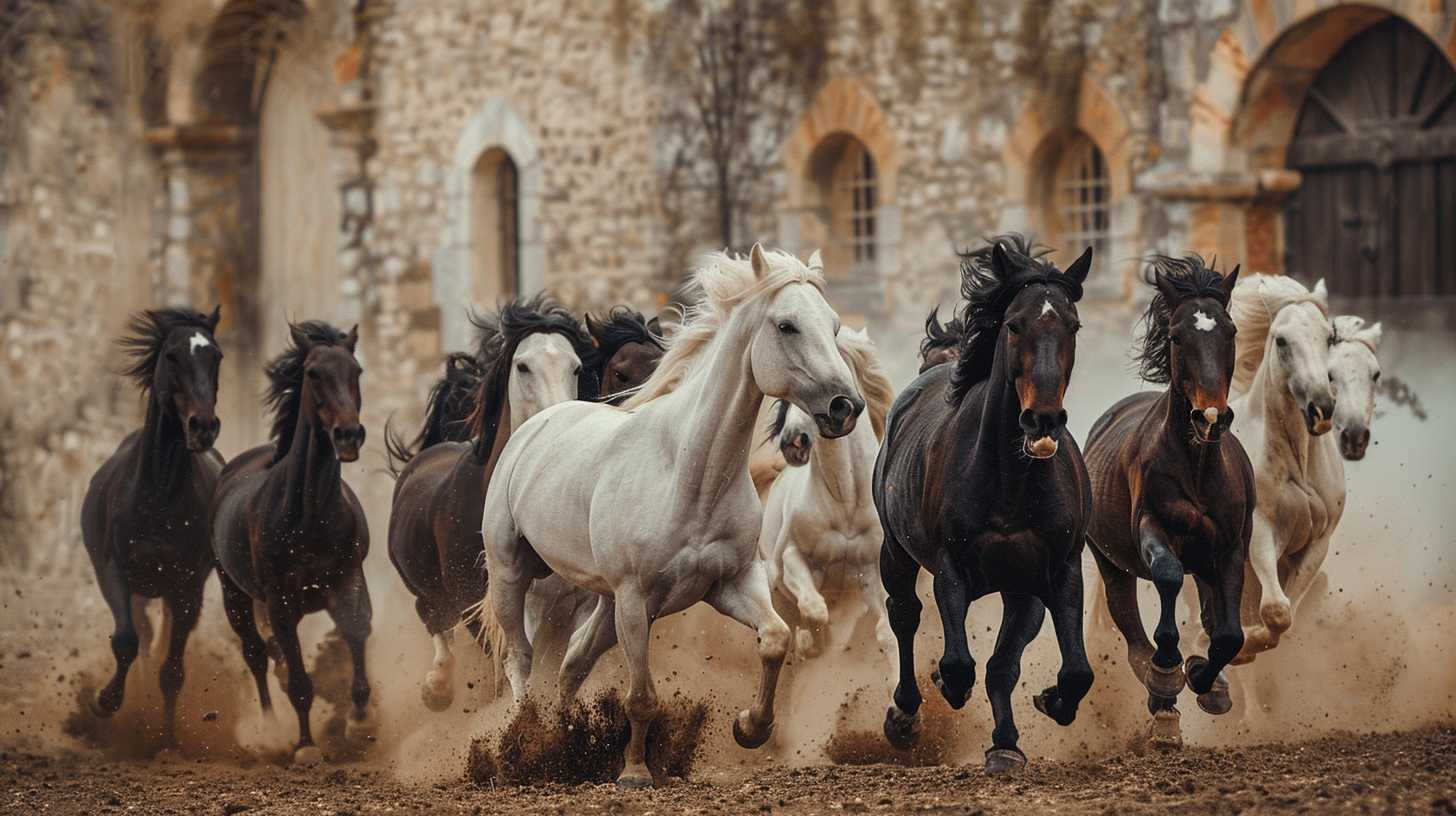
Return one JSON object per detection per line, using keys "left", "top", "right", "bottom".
{"left": 703, "top": 560, "right": 789, "bottom": 748}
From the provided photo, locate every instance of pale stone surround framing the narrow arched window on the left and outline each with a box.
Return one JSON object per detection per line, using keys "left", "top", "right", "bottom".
{"left": 431, "top": 96, "right": 546, "bottom": 351}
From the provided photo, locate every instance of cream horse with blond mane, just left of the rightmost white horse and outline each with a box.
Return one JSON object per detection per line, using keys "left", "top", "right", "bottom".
{"left": 1229, "top": 274, "right": 1345, "bottom": 663}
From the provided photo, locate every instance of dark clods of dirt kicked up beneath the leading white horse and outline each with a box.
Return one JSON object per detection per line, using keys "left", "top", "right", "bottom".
{"left": 466, "top": 689, "right": 708, "bottom": 785}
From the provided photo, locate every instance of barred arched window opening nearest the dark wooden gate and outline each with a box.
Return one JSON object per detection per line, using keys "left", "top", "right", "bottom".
{"left": 1053, "top": 131, "right": 1112, "bottom": 258}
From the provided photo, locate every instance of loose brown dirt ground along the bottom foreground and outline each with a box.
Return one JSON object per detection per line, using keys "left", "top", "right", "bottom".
{"left": 0, "top": 727, "right": 1456, "bottom": 816}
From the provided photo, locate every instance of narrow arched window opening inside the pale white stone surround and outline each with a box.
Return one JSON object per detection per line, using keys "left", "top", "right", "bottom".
{"left": 470, "top": 147, "right": 521, "bottom": 306}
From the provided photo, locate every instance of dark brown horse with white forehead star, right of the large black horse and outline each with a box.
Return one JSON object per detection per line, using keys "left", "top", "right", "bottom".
{"left": 1086, "top": 255, "right": 1254, "bottom": 742}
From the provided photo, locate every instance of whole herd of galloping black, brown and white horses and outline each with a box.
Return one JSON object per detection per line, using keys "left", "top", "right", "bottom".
{"left": 82, "top": 235, "right": 1380, "bottom": 787}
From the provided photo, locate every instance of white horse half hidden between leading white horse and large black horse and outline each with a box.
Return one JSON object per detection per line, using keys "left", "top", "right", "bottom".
{"left": 754, "top": 329, "right": 898, "bottom": 686}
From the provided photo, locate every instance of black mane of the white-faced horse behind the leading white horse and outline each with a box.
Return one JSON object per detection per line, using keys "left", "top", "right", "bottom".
{"left": 466, "top": 293, "right": 598, "bottom": 463}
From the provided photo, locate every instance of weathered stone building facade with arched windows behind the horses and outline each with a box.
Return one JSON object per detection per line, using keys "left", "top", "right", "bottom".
{"left": 0, "top": 0, "right": 1456, "bottom": 557}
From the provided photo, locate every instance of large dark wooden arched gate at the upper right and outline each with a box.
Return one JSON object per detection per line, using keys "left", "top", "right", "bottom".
{"left": 1284, "top": 17, "right": 1456, "bottom": 297}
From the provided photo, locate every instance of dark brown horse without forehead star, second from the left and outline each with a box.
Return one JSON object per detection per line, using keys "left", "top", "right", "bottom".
{"left": 213, "top": 321, "right": 373, "bottom": 765}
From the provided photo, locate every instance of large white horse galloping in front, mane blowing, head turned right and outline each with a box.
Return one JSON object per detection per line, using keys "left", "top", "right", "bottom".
{"left": 482, "top": 245, "right": 865, "bottom": 787}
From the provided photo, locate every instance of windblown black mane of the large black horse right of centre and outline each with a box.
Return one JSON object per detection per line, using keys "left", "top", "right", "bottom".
{"left": 946, "top": 232, "right": 1082, "bottom": 404}
